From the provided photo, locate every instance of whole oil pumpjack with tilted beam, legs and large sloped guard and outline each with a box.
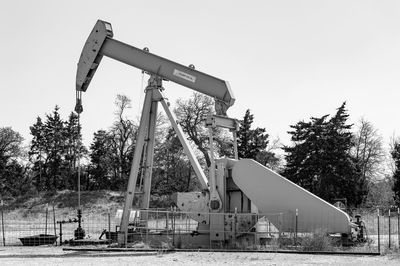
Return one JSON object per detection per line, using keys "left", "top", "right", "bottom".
{"left": 76, "top": 20, "right": 366, "bottom": 248}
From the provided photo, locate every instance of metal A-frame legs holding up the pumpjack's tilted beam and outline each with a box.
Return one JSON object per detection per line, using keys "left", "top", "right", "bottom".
{"left": 118, "top": 75, "right": 208, "bottom": 245}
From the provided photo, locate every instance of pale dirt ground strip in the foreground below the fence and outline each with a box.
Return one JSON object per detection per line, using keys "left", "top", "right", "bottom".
{"left": 0, "top": 246, "right": 400, "bottom": 266}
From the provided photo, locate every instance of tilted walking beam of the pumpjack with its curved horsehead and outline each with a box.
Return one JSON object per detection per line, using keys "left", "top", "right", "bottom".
{"left": 76, "top": 20, "right": 235, "bottom": 115}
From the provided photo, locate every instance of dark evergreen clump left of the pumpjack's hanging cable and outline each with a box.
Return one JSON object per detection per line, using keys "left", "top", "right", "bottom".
{"left": 29, "top": 106, "right": 85, "bottom": 191}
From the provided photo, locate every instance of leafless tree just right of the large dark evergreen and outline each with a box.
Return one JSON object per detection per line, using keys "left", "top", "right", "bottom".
{"left": 353, "top": 118, "right": 386, "bottom": 181}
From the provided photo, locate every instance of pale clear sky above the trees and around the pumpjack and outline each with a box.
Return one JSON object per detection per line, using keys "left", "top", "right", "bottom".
{"left": 0, "top": 0, "right": 400, "bottom": 150}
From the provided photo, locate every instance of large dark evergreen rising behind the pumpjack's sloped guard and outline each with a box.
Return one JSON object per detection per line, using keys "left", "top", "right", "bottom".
{"left": 282, "top": 103, "right": 367, "bottom": 205}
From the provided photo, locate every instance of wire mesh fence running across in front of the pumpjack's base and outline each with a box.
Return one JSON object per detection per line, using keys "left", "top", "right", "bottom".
{"left": 0, "top": 207, "right": 400, "bottom": 252}
